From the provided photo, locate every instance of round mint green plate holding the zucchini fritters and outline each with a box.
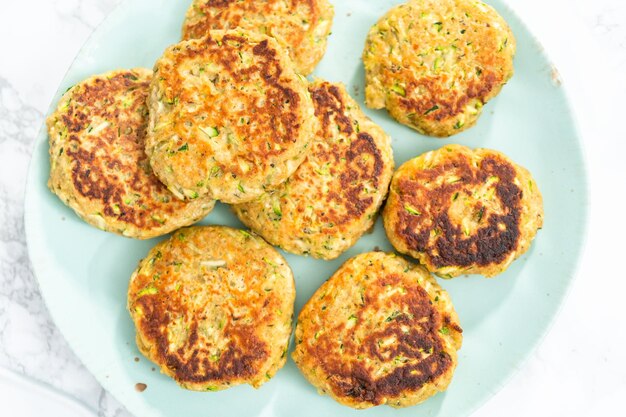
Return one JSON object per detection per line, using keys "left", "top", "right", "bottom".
{"left": 26, "top": 0, "right": 587, "bottom": 417}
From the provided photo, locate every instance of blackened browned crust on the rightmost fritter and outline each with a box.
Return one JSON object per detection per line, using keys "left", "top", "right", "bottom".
{"left": 394, "top": 155, "right": 522, "bottom": 268}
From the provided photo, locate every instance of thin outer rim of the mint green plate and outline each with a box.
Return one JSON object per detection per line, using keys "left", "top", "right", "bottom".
{"left": 23, "top": 0, "right": 591, "bottom": 415}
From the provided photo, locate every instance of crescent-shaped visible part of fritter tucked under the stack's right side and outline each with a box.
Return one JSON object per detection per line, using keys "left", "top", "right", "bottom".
{"left": 233, "top": 80, "right": 393, "bottom": 259}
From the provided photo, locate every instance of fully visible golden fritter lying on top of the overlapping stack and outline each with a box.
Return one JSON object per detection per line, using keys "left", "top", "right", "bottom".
{"left": 146, "top": 30, "right": 314, "bottom": 203}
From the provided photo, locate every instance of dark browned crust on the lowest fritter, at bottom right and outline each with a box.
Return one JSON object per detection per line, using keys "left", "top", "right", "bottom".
{"left": 308, "top": 275, "right": 454, "bottom": 405}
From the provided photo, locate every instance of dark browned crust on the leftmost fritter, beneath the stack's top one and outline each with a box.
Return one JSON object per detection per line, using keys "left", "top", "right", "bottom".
{"left": 62, "top": 73, "right": 156, "bottom": 228}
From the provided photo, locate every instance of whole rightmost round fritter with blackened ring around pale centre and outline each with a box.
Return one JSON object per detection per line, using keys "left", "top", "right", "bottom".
{"left": 383, "top": 145, "right": 543, "bottom": 278}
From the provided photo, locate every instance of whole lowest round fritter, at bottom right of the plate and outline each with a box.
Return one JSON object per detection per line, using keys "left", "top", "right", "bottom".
{"left": 292, "top": 252, "right": 462, "bottom": 408}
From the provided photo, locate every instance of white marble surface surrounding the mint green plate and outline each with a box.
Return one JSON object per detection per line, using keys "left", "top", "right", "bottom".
{"left": 0, "top": 0, "right": 626, "bottom": 417}
